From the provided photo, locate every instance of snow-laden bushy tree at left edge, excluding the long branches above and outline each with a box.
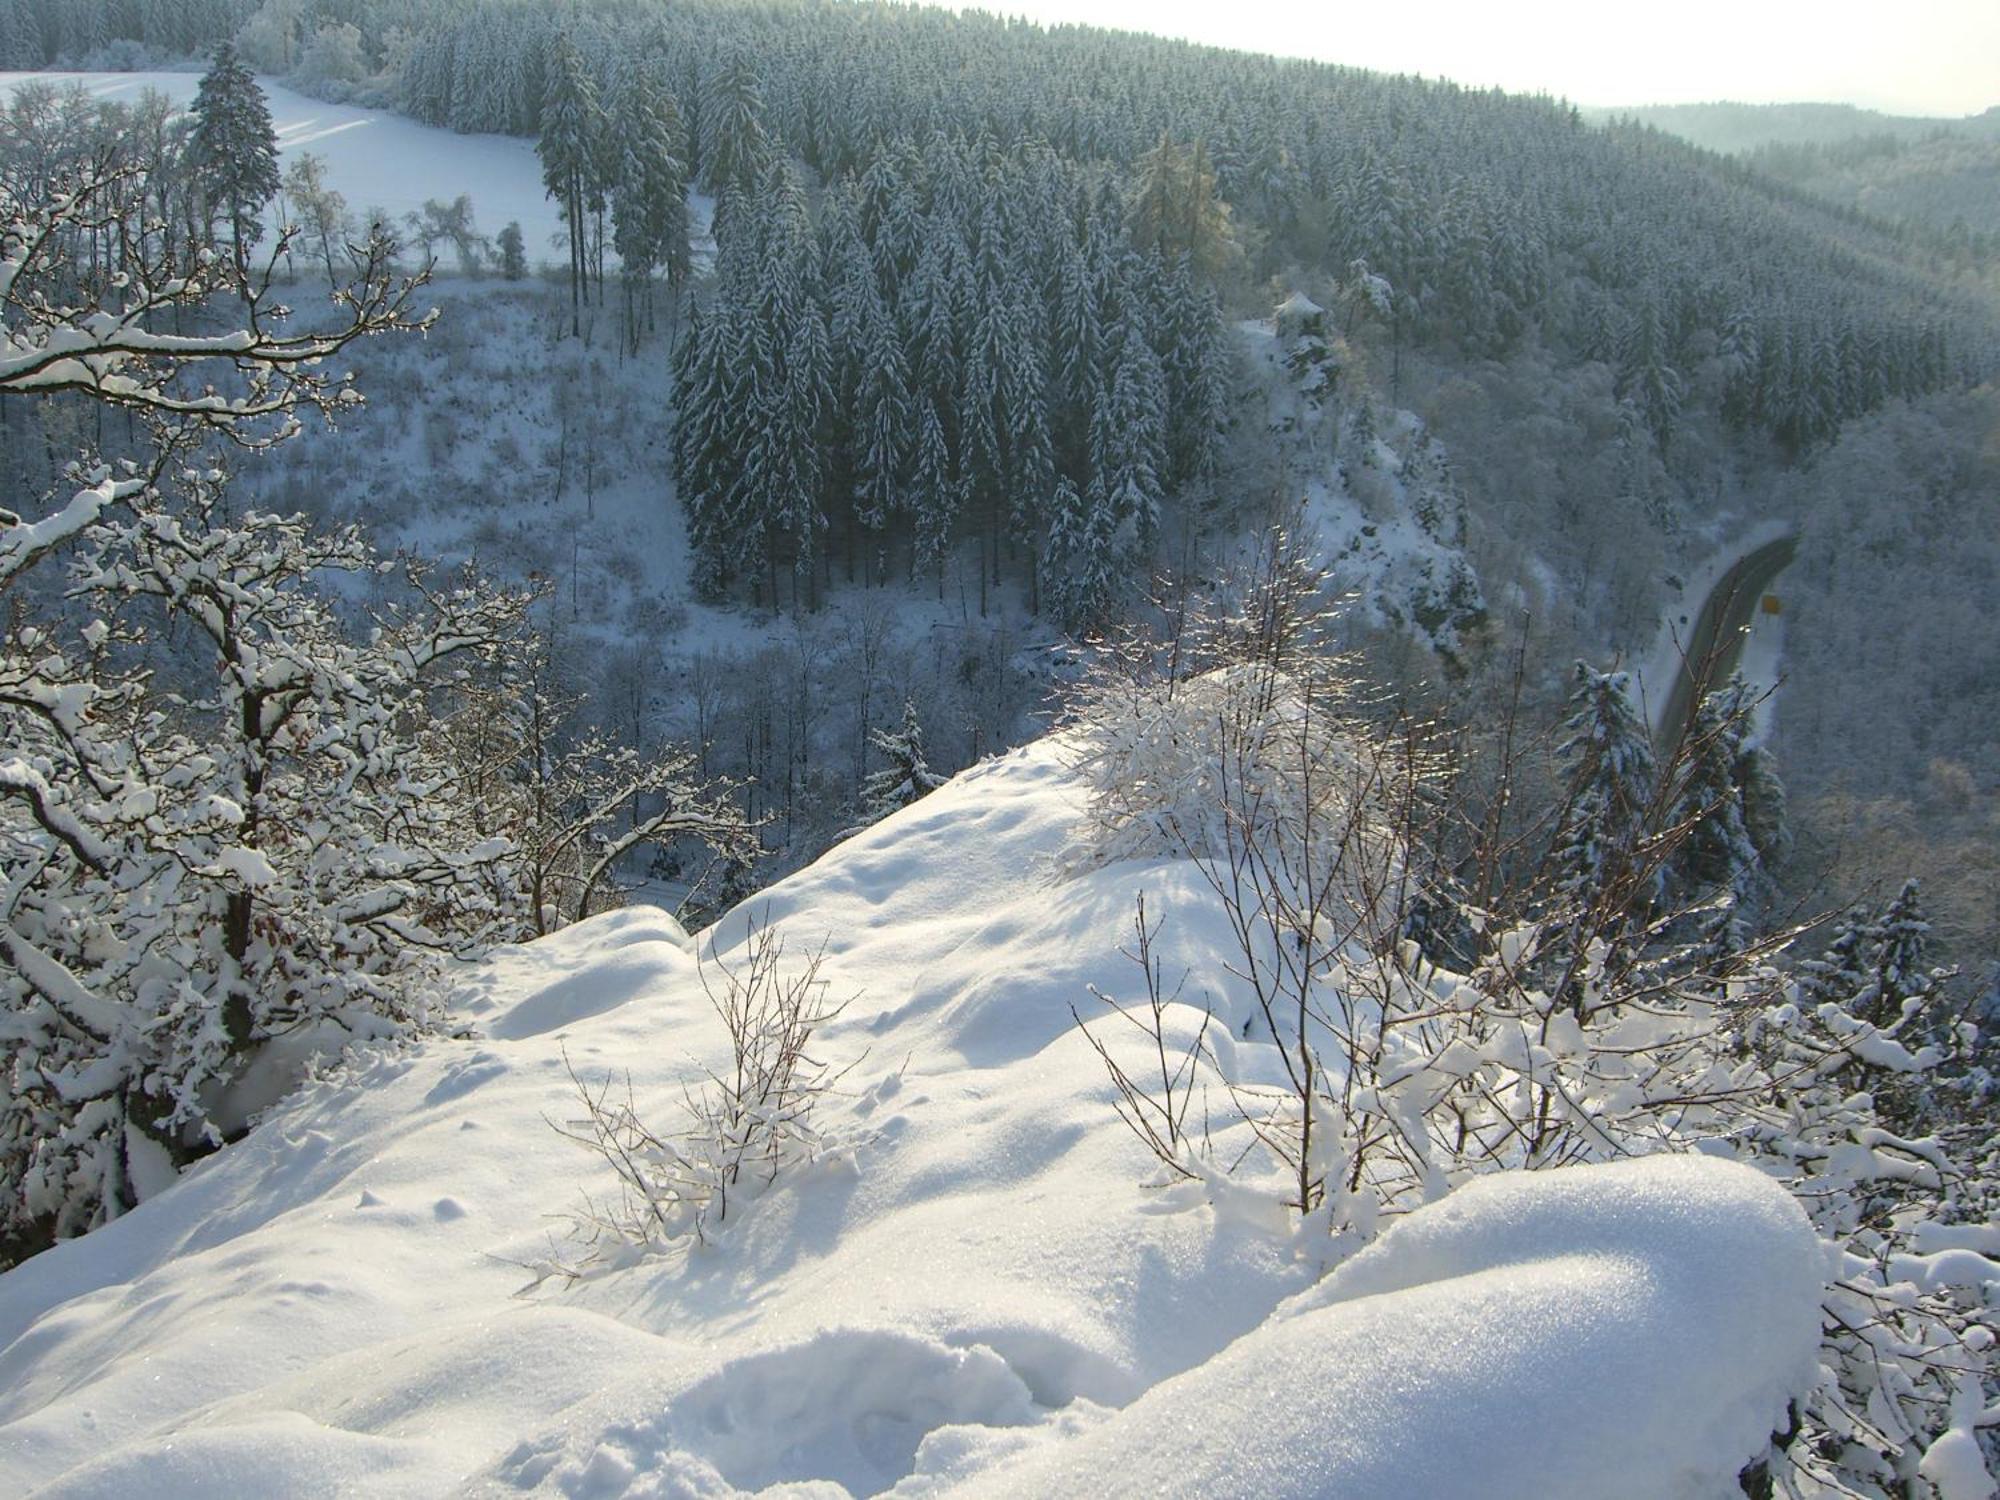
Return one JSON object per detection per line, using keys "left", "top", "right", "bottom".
{"left": 0, "top": 472, "right": 548, "bottom": 1234}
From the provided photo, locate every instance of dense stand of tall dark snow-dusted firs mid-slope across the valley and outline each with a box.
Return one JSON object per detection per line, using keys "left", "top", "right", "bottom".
{"left": 674, "top": 125, "right": 1230, "bottom": 622}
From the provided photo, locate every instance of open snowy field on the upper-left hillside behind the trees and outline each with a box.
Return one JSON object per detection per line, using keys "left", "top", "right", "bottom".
{"left": 0, "top": 72, "right": 568, "bottom": 264}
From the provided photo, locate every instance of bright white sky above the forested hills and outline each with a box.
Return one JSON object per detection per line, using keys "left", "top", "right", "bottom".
{"left": 956, "top": 0, "right": 2000, "bottom": 114}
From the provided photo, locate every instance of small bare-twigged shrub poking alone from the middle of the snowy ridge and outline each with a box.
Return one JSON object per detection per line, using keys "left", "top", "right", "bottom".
{"left": 548, "top": 920, "right": 854, "bottom": 1276}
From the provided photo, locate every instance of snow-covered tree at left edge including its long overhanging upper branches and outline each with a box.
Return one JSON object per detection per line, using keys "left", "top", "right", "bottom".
{"left": 0, "top": 159, "right": 434, "bottom": 1238}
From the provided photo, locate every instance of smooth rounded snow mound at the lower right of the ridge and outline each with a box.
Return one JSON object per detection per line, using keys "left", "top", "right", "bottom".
{"left": 964, "top": 1156, "right": 1820, "bottom": 1500}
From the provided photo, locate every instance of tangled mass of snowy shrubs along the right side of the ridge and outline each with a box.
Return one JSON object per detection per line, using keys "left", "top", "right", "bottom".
{"left": 1070, "top": 572, "right": 2000, "bottom": 1496}
